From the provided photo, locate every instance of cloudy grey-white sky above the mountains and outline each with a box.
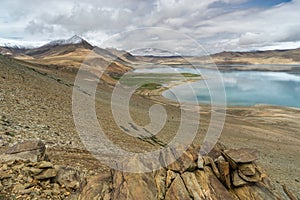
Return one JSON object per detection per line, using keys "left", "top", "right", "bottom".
{"left": 0, "top": 0, "right": 300, "bottom": 55}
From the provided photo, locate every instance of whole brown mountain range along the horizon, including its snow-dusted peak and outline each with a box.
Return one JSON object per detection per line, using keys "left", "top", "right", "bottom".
{"left": 0, "top": 35, "right": 300, "bottom": 79}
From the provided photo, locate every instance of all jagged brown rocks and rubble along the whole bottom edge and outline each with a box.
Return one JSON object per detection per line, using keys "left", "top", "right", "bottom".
{"left": 0, "top": 141, "right": 296, "bottom": 200}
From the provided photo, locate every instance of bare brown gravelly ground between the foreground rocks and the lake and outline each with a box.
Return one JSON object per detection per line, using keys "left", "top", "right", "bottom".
{"left": 0, "top": 55, "right": 300, "bottom": 198}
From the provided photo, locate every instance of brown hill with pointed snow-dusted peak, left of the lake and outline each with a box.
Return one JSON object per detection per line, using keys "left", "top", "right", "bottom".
{"left": 0, "top": 35, "right": 134, "bottom": 84}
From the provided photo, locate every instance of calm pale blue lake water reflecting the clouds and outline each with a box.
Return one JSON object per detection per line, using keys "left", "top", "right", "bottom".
{"left": 134, "top": 68, "right": 300, "bottom": 107}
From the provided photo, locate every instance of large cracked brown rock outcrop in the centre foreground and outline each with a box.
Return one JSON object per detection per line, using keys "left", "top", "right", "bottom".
{"left": 81, "top": 145, "right": 293, "bottom": 200}
